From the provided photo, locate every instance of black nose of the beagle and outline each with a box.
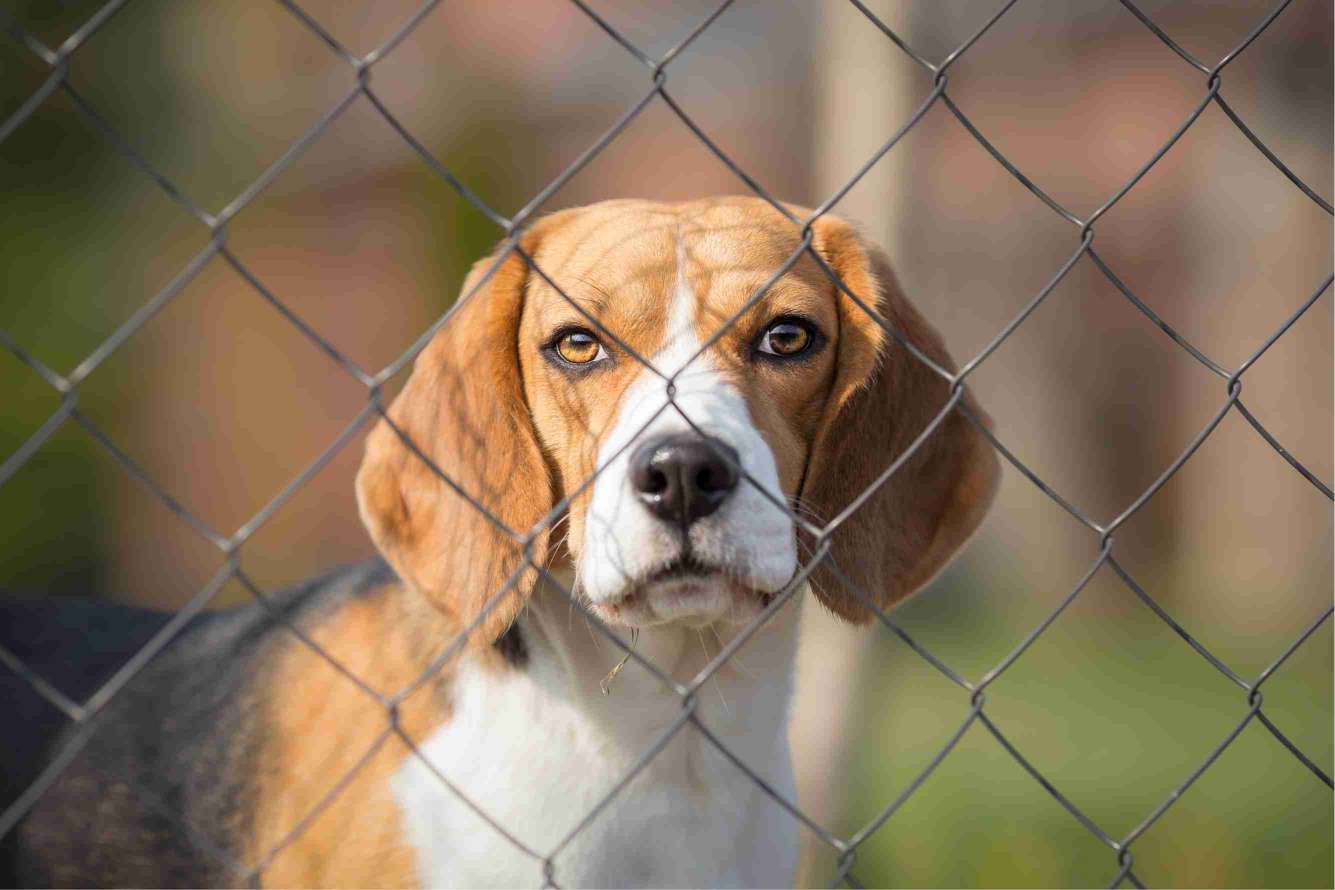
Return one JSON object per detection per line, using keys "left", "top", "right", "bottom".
{"left": 630, "top": 432, "right": 741, "bottom": 528}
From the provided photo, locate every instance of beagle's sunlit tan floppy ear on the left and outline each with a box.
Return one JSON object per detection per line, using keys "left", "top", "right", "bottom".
{"left": 356, "top": 234, "right": 554, "bottom": 643}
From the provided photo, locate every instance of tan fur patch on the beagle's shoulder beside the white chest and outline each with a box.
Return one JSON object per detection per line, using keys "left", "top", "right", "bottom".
{"left": 250, "top": 584, "right": 506, "bottom": 887}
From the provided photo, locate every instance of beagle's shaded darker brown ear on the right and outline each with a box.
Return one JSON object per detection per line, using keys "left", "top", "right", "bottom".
{"left": 800, "top": 217, "right": 999, "bottom": 623}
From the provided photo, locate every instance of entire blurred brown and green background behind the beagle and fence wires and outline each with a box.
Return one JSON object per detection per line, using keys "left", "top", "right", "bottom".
{"left": 0, "top": 0, "right": 1335, "bottom": 886}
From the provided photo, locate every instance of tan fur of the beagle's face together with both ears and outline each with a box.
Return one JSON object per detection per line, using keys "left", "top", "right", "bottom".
{"left": 358, "top": 197, "right": 997, "bottom": 629}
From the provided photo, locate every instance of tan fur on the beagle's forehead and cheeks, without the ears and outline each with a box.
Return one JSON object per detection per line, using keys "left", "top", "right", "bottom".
{"left": 519, "top": 199, "right": 836, "bottom": 555}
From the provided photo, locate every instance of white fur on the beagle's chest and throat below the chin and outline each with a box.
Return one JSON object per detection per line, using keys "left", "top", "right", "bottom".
{"left": 392, "top": 591, "right": 797, "bottom": 887}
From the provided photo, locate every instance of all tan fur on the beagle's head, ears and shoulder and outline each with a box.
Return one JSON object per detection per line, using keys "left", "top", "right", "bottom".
{"left": 333, "top": 197, "right": 997, "bottom": 886}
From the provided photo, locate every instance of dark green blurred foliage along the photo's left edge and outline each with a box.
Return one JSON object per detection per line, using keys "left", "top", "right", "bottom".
{"left": 0, "top": 1, "right": 160, "bottom": 594}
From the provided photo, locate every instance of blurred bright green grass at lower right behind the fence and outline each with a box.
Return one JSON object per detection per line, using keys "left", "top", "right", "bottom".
{"left": 848, "top": 562, "right": 1335, "bottom": 887}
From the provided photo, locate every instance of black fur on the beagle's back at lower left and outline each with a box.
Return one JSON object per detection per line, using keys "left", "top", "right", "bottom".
{"left": 0, "top": 560, "right": 394, "bottom": 886}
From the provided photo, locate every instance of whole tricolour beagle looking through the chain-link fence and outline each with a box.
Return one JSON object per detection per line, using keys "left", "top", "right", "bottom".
{"left": 5, "top": 197, "right": 997, "bottom": 887}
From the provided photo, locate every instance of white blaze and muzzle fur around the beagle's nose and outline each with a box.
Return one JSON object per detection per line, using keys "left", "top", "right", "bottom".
{"left": 578, "top": 240, "right": 797, "bottom": 603}
